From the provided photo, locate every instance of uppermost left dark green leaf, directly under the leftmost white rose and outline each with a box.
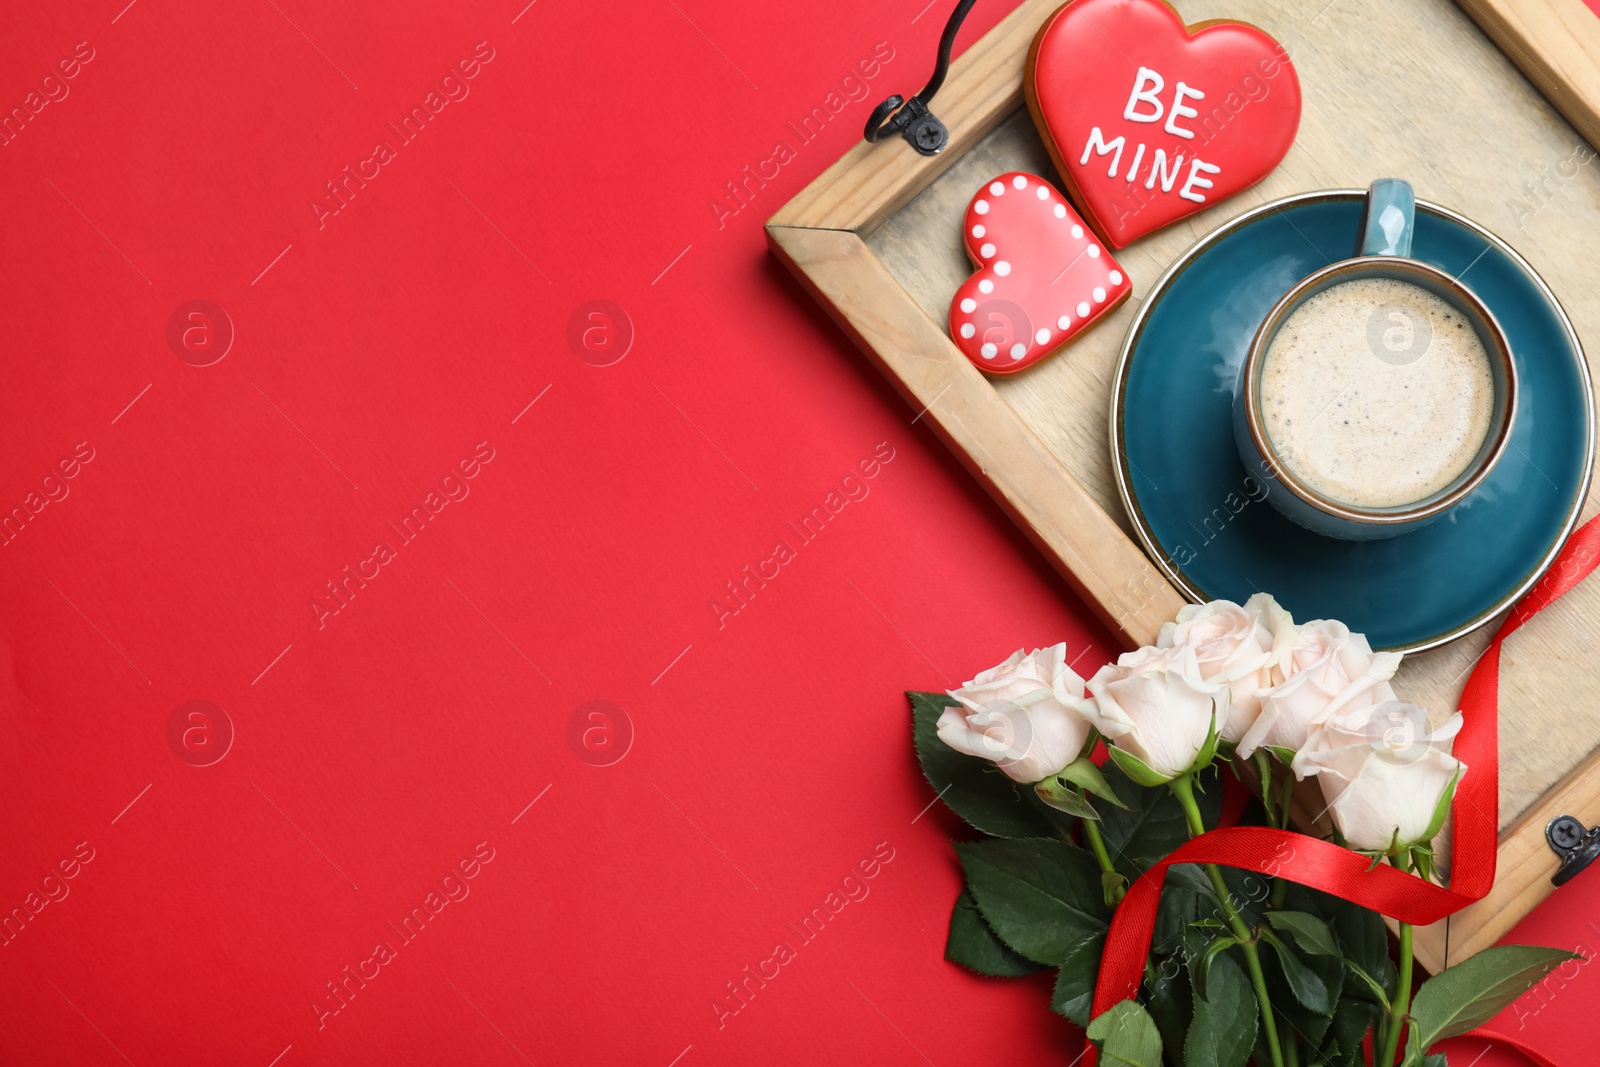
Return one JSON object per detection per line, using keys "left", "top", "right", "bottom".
{"left": 906, "top": 693, "right": 1056, "bottom": 837}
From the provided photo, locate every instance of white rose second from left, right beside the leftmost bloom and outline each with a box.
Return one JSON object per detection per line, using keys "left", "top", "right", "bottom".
{"left": 1083, "top": 645, "right": 1229, "bottom": 777}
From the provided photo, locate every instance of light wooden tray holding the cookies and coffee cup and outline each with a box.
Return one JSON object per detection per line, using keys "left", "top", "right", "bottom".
{"left": 766, "top": 0, "right": 1600, "bottom": 969}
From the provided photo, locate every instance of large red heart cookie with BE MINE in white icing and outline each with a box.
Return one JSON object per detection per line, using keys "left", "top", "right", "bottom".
{"left": 1026, "top": 0, "right": 1301, "bottom": 248}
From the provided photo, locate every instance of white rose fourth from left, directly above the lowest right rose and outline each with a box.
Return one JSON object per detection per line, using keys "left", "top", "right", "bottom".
{"left": 1238, "top": 619, "right": 1400, "bottom": 760}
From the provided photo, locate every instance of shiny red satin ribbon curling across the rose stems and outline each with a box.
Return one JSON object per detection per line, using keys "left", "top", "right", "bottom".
{"left": 1083, "top": 518, "right": 1600, "bottom": 1067}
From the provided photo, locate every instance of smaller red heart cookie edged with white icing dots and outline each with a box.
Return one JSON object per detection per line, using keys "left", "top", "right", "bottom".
{"left": 950, "top": 171, "right": 1133, "bottom": 374}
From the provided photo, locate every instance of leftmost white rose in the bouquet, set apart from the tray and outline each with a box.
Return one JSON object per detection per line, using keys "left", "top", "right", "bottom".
{"left": 938, "top": 643, "right": 1090, "bottom": 782}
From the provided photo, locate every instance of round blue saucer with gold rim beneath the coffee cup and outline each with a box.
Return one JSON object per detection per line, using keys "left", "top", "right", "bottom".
{"left": 1110, "top": 190, "right": 1595, "bottom": 651}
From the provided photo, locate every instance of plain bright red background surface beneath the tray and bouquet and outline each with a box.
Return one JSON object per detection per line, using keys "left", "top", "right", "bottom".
{"left": 0, "top": 0, "right": 1592, "bottom": 1067}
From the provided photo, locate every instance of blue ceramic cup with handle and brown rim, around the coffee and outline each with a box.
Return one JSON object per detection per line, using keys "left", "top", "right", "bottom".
{"left": 1234, "top": 178, "right": 1517, "bottom": 541}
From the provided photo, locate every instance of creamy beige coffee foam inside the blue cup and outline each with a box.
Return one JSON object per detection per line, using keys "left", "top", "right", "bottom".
{"left": 1259, "top": 278, "right": 1494, "bottom": 509}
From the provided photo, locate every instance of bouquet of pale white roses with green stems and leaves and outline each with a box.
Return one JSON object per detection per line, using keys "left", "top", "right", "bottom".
{"left": 909, "top": 593, "right": 1576, "bottom": 1067}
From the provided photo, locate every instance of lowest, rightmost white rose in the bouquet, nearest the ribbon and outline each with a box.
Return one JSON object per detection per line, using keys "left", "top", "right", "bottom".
{"left": 1294, "top": 701, "right": 1467, "bottom": 853}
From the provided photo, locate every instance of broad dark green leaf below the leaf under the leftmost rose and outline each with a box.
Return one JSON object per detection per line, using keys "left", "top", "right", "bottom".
{"left": 955, "top": 838, "right": 1110, "bottom": 966}
